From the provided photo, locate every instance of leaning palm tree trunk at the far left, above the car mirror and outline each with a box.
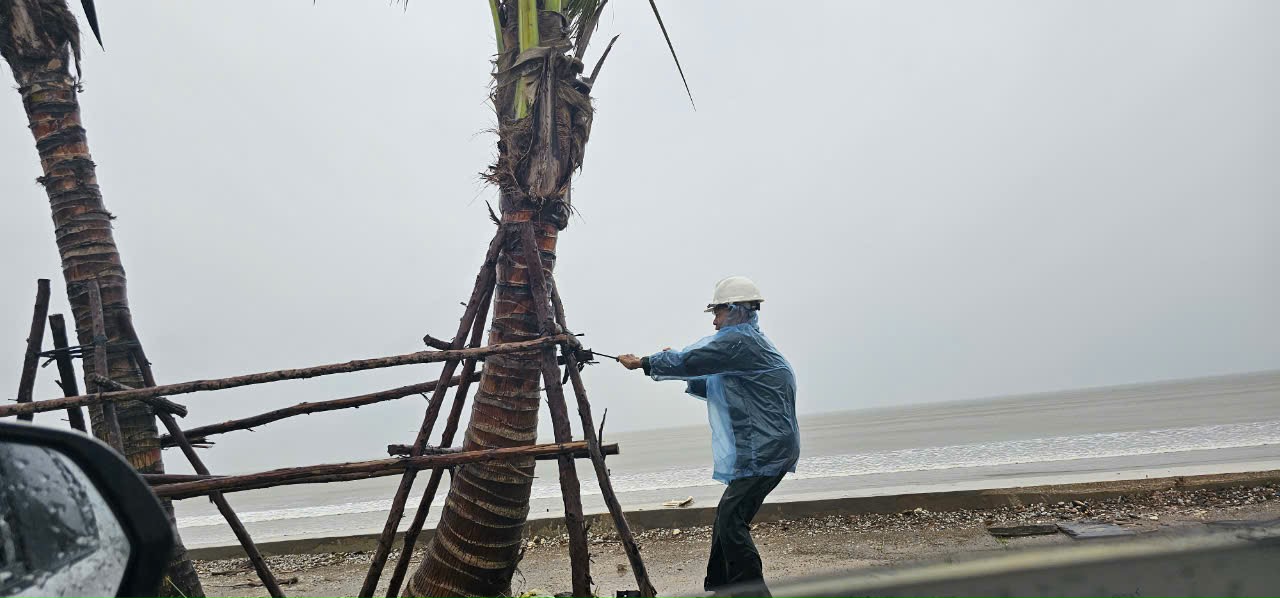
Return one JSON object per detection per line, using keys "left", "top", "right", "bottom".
{"left": 0, "top": 0, "right": 204, "bottom": 598}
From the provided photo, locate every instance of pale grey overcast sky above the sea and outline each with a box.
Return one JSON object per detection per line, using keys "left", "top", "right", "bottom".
{"left": 0, "top": 0, "right": 1280, "bottom": 471}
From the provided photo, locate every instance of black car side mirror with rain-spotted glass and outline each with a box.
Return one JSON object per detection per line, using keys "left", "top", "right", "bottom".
{"left": 0, "top": 424, "right": 174, "bottom": 598}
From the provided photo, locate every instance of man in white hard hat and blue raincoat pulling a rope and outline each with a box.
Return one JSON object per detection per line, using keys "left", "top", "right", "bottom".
{"left": 618, "top": 277, "right": 800, "bottom": 595}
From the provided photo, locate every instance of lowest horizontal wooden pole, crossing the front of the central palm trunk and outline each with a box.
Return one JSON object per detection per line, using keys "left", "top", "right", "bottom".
{"left": 155, "top": 442, "right": 599, "bottom": 501}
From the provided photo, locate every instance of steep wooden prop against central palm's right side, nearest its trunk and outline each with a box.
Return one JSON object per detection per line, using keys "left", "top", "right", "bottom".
{"left": 521, "top": 224, "right": 591, "bottom": 598}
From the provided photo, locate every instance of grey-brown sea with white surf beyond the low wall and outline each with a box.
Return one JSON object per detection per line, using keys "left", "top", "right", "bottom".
{"left": 175, "top": 371, "right": 1280, "bottom": 548}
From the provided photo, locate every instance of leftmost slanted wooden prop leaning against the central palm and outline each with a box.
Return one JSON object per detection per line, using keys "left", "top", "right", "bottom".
{"left": 360, "top": 227, "right": 506, "bottom": 598}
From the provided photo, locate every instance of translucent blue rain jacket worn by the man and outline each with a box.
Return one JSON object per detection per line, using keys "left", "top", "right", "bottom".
{"left": 649, "top": 305, "right": 800, "bottom": 484}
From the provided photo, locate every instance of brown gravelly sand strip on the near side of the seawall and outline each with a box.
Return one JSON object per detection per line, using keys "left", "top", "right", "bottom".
{"left": 197, "top": 484, "right": 1280, "bottom": 598}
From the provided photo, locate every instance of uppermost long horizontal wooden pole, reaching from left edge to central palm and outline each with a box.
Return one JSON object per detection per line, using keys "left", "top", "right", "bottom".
{"left": 0, "top": 335, "right": 577, "bottom": 417}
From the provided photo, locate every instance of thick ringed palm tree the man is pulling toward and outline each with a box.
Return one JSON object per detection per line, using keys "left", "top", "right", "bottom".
{"left": 404, "top": 0, "right": 691, "bottom": 598}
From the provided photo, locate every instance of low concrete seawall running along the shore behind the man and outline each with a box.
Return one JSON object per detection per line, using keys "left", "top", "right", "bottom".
{"left": 188, "top": 470, "right": 1280, "bottom": 560}
